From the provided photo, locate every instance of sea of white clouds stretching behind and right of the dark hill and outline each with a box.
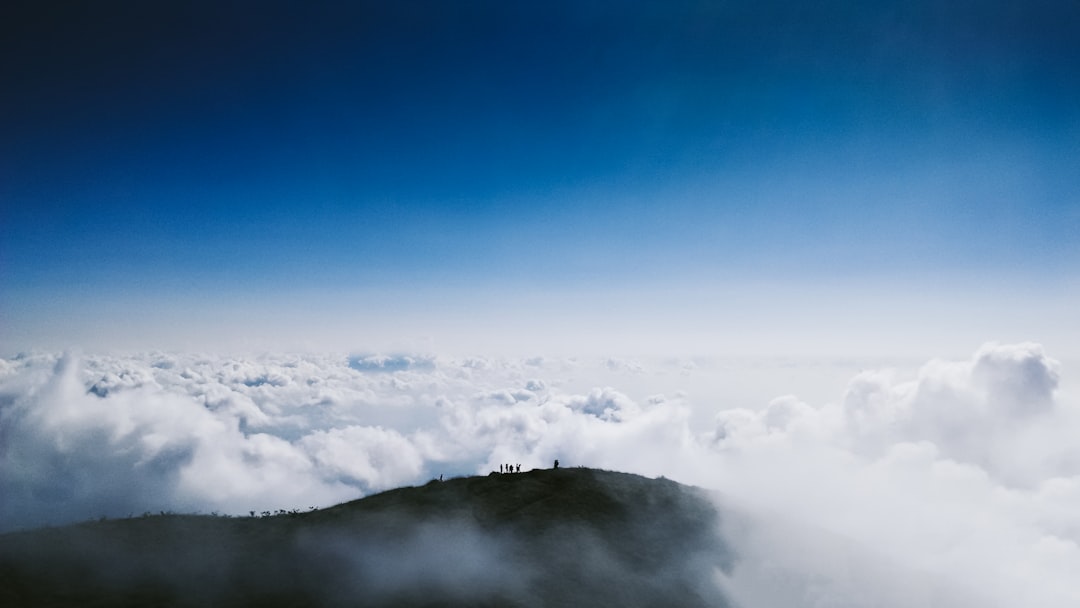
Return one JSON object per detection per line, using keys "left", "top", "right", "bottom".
{"left": 0, "top": 343, "right": 1080, "bottom": 608}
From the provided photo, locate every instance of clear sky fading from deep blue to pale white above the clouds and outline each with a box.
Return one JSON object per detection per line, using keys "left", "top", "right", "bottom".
{"left": 0, "top": 1, "right": 1080, "bottom": 355}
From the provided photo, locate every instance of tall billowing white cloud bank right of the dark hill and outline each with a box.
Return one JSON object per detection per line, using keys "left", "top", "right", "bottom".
{"left": 699, "top": 344, "right": 1080, "bottom": 606}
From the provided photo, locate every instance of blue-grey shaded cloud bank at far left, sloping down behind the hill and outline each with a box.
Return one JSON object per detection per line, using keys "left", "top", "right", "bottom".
{"left": 0, "top": 355, "right": 354, "bottom": 527}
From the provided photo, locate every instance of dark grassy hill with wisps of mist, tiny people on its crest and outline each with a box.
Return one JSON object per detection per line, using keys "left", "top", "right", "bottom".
{"left": 0, "top": 469, "right": 731, "bottom": 607}
